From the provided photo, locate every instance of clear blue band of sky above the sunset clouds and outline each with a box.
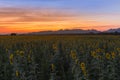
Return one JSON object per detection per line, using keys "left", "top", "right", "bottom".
{"left": 0, "top": 0, "right": 120, "bottom": 13}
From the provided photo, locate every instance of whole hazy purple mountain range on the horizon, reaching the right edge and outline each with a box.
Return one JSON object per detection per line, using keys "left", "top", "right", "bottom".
{"left": 25, "top": 28, "right": 120, "bottom": 35}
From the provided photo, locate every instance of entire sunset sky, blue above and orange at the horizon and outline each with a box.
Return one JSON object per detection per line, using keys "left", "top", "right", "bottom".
{"left": 0, "top": 0, "right": 120, "bottom": 34}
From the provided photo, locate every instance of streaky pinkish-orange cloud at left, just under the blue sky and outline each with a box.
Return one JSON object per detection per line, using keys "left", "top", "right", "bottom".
{"left": 0, "top": 7, "right": 75, "bottom": 22}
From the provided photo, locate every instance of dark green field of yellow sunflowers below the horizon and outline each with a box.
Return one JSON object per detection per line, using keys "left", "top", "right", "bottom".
{"left": 0, "top": 35, "right": 120, "bottom": 80}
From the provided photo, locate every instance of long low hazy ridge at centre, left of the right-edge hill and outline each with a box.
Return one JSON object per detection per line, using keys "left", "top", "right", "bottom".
{"left": 28, "top": 29, "right": 100, "bottom": 35}
